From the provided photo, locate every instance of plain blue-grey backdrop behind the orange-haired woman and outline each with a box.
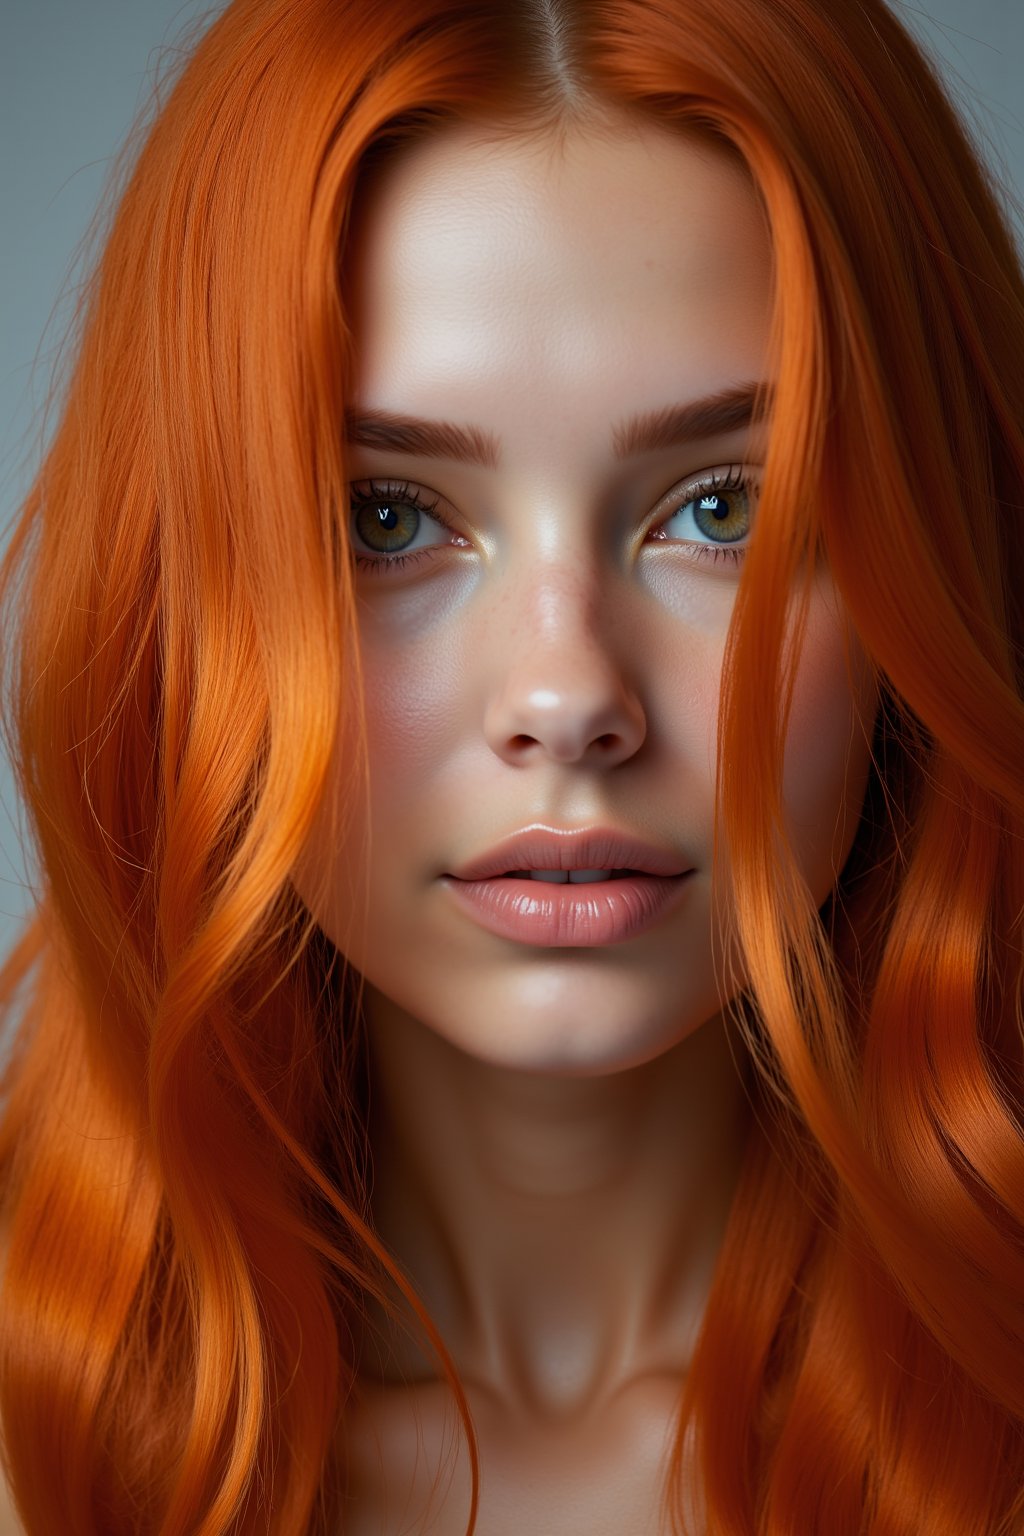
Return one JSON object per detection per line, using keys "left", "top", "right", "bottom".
{"left": 0, "top": 0, "right": 1024, "bottom": 952}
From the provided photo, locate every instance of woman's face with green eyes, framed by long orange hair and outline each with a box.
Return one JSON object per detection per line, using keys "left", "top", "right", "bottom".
{"left": 295, "top": 121, "right": 874, "bottom": 1075}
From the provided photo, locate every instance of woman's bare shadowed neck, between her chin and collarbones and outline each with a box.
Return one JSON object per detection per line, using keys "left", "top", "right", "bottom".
{"left": 359, "top": 989, "right": 749, "bottom": 1416}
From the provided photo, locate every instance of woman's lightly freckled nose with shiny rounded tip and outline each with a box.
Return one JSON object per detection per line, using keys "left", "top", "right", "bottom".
{"left": 484, "top": 571, "right": 646, "bottom": 768}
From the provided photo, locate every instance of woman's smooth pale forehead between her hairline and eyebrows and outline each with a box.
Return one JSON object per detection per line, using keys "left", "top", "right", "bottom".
{"left": 345, "top": 115, "right": 771, "bottom": 448}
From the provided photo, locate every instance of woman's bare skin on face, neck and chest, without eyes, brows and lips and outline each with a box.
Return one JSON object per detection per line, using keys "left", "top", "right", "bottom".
{"left": 295, "top": 121, "right": 875, "bottom": 1536}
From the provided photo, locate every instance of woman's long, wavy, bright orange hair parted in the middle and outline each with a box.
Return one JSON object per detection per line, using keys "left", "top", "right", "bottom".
{"left": 0, "top": 0, "right": 1024, "bottom": 1536}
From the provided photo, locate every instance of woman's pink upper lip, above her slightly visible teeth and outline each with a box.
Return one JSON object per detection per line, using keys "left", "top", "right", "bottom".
{"left": 451, "top": 826, "right": 691, "bottom": 880}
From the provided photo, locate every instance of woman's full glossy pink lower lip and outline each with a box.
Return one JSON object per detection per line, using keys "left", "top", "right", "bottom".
{"left": 442, "top": 869, "right": 694, "bottom": 948}
